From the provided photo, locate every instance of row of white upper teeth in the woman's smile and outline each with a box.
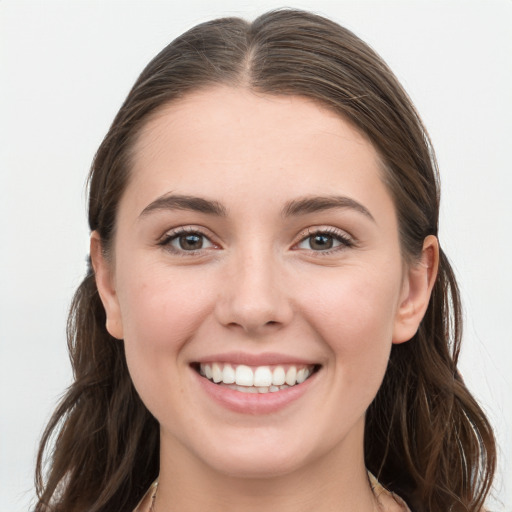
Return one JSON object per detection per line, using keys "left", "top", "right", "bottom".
{"left": 200, "top": 363, "right": 312, "bottom": 387}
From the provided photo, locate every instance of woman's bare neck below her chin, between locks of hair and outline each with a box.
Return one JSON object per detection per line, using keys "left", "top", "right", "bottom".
{"left": 154, "top": 426, "right": 378, "bottom": 512}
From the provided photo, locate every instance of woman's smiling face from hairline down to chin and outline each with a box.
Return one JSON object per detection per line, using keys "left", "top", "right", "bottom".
{"left": 92, "top": 87, "right": 432, "bottom": 476}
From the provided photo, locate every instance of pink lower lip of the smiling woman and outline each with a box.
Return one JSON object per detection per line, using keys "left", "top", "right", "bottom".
{"left": 193, "top": 370, "right": 318, "bottom": 415}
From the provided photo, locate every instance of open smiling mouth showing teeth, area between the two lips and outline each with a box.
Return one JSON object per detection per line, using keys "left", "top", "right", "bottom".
{"left": 193, "top": 363, "right": 320, "bottom": 393}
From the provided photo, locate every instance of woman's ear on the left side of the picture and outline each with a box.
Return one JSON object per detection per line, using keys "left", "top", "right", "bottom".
{"left": 90, "top": 231, "right": 123, "bottom": 340}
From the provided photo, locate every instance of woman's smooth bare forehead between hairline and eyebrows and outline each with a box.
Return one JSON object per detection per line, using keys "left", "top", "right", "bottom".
{"left": 129, "top": 87, "right": 390, "bottom": 216}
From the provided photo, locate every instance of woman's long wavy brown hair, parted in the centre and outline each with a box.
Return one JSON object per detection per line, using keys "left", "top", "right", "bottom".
{"left": 35, "top": 9, "right": 496, "bottom": 512}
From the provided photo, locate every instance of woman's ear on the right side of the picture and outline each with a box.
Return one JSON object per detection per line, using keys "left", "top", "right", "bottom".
{"left": 393, "top": 235, "right": 439, "bottom": 344}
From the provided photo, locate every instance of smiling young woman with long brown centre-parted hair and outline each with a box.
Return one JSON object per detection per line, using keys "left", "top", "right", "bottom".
{"left": 36, "top": 10, "right": 495, "bottom": 512}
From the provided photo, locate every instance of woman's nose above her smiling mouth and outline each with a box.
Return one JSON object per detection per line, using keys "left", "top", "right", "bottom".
{"left": 212, "top": 245, "right": 293, "bottom": 336}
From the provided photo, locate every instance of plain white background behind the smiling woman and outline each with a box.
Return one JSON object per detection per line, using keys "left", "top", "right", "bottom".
{"left": 0, "top": 0, "right": 512, "bottom": 512}
